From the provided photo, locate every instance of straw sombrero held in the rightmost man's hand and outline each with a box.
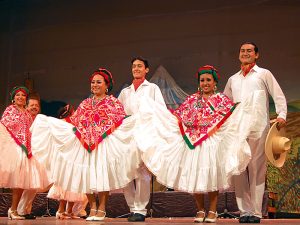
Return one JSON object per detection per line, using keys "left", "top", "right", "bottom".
{"left": 265, "top": 122, "right": 291, "bottom": 167}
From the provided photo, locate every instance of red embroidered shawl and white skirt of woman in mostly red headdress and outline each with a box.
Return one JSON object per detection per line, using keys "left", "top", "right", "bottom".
{"left": 31, "top": 96, "right": 138, "bottom": 201}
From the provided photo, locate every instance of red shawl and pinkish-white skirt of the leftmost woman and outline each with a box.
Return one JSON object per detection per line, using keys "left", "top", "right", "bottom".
{"left": 0, "top": 105, "right": 50, "bottom": 189}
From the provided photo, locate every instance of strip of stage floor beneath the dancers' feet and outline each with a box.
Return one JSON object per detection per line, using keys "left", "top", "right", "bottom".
{"left": 0, "top": 217, "right": 300, "bottom": 225}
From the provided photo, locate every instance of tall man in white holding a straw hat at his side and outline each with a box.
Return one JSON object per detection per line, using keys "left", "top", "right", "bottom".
{"left": 224, "top": 42, "right": 287, "bottom": 223}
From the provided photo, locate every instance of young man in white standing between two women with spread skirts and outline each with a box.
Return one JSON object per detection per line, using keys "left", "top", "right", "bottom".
{"left": 118, "top": 57, "right": 166, "bottom": 222}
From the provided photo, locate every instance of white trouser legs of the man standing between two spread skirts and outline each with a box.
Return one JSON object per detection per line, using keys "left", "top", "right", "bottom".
{"left": 124, "top": 165, "right": 151, "bottom": 215}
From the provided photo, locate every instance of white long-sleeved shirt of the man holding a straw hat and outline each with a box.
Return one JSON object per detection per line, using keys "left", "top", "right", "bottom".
{"left": 224, "top": 65, "right": 287, "bottom": 120}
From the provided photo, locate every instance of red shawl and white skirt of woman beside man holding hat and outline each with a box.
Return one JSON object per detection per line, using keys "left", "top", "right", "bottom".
{"left": 135, "top": 91, "right": 265, "bottom": 193}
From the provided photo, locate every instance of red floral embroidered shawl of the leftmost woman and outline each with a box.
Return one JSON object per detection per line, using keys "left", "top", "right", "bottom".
{"left": 1, "top": 105, "right": 32, "bottom": 158}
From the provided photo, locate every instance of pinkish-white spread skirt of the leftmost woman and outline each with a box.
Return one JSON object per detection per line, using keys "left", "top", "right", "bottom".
{"left": 0, "top": 123, "right": 50, "bottom": 189}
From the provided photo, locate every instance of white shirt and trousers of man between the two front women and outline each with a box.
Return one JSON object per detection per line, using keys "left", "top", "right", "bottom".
{"left": 118, "top": 80, "right": 166, "bottom": 215}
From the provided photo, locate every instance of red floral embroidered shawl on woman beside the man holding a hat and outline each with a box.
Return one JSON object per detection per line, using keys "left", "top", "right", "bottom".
{"left": 173, "top": 93, "right": 235, "bottom": 148}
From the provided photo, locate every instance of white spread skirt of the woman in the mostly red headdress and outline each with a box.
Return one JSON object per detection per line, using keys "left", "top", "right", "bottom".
{"left": 31, "top": 115, "right": 139, "bottom": 194}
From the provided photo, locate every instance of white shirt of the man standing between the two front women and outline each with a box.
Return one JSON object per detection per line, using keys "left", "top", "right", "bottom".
{"left": 118, "top": 80, "right": 166, "bottom": 115}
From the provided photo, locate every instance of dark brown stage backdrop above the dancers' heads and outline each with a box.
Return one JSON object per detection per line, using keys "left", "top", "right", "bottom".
{"left": 0, "top": 0, "right": 300, "bottom": 113}
